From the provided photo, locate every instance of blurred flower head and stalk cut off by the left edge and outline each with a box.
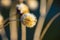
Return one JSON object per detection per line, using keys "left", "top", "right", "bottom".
{"left": 0, "top": 14, "right": 8, "bottom": 40}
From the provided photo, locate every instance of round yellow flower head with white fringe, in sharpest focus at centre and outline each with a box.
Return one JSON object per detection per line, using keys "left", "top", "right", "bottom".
{"left": 21, "top": 13, "right": 37, "bottom": 28}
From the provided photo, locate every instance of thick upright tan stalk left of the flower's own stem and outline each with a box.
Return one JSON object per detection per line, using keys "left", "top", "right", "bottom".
{"left": 10, "top": 2, "right": 18, "bottom": 40}
